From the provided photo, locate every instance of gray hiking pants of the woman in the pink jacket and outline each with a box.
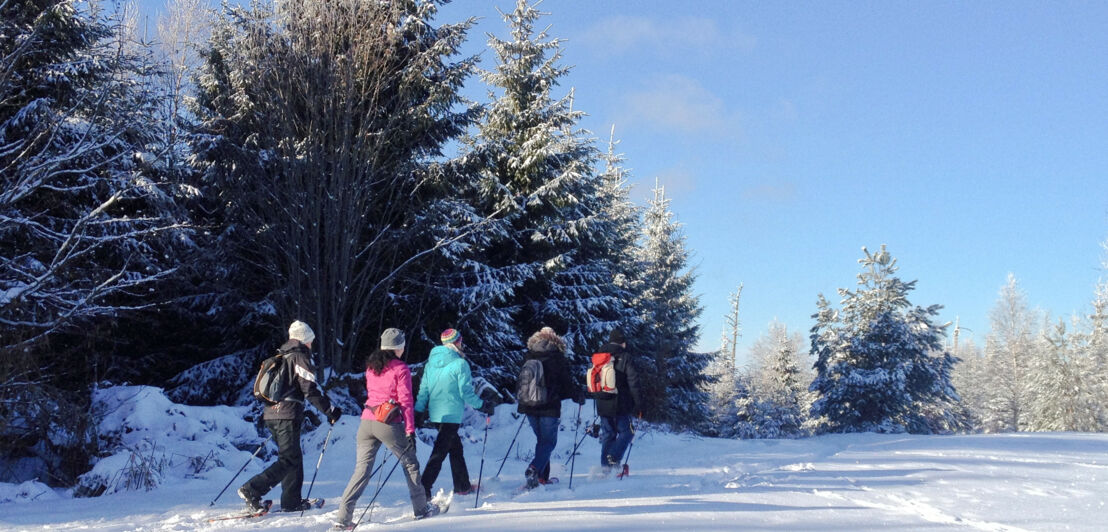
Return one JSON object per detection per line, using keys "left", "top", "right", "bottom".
{"left": 338, "top": 419, "right": 427, "bottom": 524}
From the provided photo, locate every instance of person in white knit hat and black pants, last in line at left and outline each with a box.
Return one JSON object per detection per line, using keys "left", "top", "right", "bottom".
{"left": 238, "top": 320, "right": 342, "bottom": 513}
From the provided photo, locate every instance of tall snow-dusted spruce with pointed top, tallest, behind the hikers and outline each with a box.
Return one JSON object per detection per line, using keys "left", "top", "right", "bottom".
{"left": 458, "top": 0, "right": 633, "bottom": 376}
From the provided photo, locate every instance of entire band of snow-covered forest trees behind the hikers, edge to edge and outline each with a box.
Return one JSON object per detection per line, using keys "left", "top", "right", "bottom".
{"left": 0, "top": 0, "right": 1108, "bottom": 485}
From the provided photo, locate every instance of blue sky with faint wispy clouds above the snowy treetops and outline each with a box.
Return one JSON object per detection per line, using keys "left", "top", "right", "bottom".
{"left": 138, "top": 0, "right": 1108, "bottom": 364}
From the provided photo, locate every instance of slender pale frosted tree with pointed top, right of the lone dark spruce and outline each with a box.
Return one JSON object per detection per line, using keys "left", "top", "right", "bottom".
{"left": 982, "top": 274, "right": 1043, "bottom": 432}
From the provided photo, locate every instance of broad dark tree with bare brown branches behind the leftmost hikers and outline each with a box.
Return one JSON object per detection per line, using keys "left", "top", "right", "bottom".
{"left": 193, "top": 0, "right": 476, "bottom": 370}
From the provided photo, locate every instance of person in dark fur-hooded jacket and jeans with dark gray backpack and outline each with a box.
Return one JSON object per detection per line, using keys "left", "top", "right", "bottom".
{"left": 516, "top": 327, "right": 585, "bottom": 490}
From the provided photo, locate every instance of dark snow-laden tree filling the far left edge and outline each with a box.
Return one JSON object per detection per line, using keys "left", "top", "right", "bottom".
{"left": 0, "top": 0, "right": 183, "bottom": 484}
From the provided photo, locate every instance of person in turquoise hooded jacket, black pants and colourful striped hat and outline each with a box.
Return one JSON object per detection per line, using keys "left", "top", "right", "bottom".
{"left": 416, "top": 329, "right": 493, "bottom": 498}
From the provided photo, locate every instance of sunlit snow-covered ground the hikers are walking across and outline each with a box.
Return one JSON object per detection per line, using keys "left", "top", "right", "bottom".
{"left": 0, "top": 389, "right": 1108, "bottom": 532}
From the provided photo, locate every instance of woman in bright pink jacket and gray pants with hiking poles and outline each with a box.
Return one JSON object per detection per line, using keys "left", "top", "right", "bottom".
{"left": 332, "top": 328, "right": 439, "bottom": 530}
